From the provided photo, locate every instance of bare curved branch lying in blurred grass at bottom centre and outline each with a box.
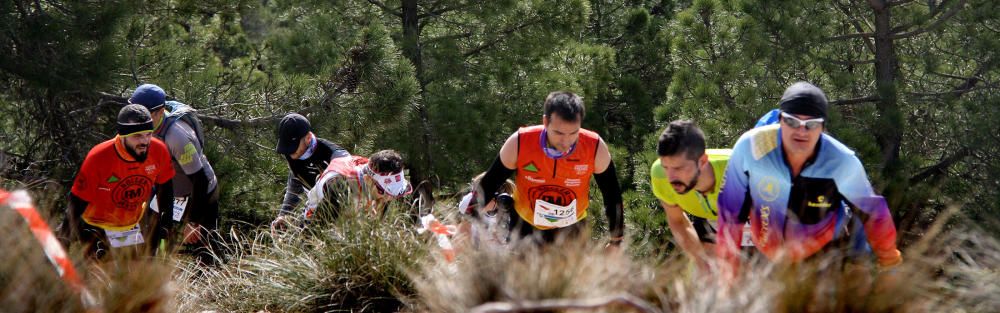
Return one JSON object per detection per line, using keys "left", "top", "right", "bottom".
{"left": 471, "top": 294, "right": 661, "bottom": 313}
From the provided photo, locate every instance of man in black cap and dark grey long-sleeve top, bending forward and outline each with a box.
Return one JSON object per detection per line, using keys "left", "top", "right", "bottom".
{"left": 271, "top": 113, "right": 351, "bottom": 229}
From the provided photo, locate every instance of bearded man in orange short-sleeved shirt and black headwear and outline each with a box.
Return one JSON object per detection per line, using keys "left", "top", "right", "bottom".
{"left": 60, "top": 104, "right": 174, "bottom": 259}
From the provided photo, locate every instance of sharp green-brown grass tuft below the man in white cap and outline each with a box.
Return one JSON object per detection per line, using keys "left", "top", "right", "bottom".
{"left": 180, "top": 197, "right": 427, "bottom": 312}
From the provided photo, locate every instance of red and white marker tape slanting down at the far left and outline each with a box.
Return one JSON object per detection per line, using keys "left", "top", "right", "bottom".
{"left": 0, "top": 189, "right": 97, "bottom": 311}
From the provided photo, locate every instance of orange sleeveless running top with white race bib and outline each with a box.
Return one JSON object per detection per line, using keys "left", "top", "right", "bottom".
{"left": 514, "top": 125, "right": 601, "bottom": 229}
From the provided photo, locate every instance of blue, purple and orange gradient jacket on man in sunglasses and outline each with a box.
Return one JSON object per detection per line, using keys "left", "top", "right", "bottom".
{"left": 717, "top": 124, "right": 901, "bottom": 266}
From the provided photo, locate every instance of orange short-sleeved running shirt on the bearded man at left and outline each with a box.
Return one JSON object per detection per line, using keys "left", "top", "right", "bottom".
{"left": 72, "top": 136, "right": 174, "bottom": 231}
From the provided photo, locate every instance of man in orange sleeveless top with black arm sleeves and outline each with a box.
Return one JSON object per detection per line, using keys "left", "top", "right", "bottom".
{"left": 472, "top": 91, "right": 624, "bottom": 246}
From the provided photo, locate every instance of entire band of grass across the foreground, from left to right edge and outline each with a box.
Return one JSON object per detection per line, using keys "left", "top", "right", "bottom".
{"left": 0, "top": 185, "right": 1000, "bottom": 312}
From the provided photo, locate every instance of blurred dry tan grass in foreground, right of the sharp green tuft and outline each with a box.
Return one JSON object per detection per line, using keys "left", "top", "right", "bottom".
{"left": 411, "top": 207, "right": 1000, "bottom": 312}
